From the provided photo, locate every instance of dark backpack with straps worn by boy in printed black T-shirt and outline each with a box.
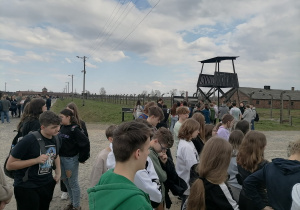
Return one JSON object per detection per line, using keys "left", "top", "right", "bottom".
{"left": 3, "top": 131, "right": 60, "bottom": 182}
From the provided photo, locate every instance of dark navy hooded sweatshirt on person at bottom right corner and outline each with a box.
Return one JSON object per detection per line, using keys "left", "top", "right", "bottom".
{"left": 243, "top": 158, "right": 300, "bottom": 210}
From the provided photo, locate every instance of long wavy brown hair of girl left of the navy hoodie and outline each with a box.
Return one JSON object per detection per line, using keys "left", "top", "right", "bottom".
{"left": 236, "top": 131, "right": 267, "bottom": 172}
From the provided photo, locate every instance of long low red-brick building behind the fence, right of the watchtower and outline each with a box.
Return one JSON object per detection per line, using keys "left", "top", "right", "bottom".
{"left": 221, "top": 86, "right": 300, "bottom": 109}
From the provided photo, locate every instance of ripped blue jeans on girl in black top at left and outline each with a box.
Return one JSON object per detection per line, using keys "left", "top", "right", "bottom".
{"left": 60, "top": 155, "right": 80, "bottom": 208}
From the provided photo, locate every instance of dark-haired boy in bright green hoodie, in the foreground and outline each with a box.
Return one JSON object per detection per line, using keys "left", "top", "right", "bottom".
{"left": 88, "top": 121, "right": 152, "bottom": 210}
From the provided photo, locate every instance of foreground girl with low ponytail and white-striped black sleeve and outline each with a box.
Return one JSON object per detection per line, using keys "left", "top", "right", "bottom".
{"left": 186, "top": 137, "right": 239, "bottom": 210}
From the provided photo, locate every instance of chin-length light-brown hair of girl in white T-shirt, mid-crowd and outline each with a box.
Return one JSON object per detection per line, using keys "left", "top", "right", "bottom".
{"left": 178, "top": 118, "right": 200, "bottom": 141}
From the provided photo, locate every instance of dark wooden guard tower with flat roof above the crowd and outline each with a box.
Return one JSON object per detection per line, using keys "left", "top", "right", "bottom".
{"left": 195, "top": 56, "right": 239, "bottom": 105}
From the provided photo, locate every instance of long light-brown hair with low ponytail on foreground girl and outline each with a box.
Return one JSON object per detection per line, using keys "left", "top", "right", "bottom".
{"left": 187, "top": 137, "right": 232, "bottom": 210}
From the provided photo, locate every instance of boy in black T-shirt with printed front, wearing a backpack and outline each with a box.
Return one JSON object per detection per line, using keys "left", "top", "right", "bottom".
{"left": 6, "top": 111, "right": 61, "bottom": 210}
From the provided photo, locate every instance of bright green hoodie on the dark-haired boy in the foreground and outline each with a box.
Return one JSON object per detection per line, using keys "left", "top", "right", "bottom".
{"left": 87, "top": 169, "right": 152, "bottom": 210}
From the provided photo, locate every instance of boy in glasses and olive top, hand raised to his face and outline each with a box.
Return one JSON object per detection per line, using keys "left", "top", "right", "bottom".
{"left": 149, "top": 127, "right": 174, "bottom": 209}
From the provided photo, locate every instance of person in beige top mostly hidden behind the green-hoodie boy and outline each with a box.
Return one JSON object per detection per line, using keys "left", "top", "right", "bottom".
{"left": 90, "top": 125, "right": 117, "bottom": 187}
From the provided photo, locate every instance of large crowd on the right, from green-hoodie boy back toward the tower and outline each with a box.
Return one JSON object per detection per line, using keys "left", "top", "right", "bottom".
{"left": 88, "top": 100, "right": 300, "bottom": 210}
